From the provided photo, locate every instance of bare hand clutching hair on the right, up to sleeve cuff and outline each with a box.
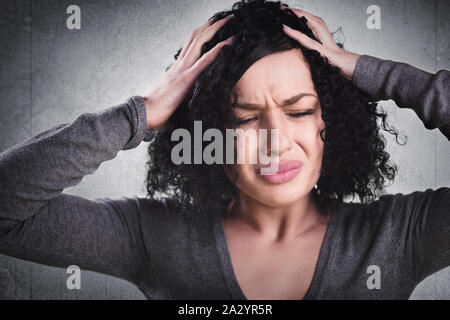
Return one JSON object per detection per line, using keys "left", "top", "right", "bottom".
{"left": 281, "top": 6, "right": 360, "bottom": 80}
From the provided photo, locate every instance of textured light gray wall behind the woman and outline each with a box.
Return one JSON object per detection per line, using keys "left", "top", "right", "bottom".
{"left": 0, "top": 0, "right": 450, "bottom": 299}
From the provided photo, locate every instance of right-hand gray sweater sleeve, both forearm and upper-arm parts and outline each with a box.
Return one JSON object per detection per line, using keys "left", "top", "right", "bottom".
{"left": 353, "top": 55, "right": 450, "bottom": 283}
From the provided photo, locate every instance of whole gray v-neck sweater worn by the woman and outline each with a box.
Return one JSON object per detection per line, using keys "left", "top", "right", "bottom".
{"left": 0, "top": 55, "right": 450, "bottom": 299}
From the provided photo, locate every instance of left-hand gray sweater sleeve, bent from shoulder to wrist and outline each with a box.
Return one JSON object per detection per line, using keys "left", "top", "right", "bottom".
{"left": 0, "top": 96, "right": 156, "bottom": 282}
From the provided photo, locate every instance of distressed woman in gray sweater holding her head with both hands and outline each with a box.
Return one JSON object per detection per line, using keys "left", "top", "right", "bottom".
{"left": 0, "top": 1, "right": 450, "bottom": 299}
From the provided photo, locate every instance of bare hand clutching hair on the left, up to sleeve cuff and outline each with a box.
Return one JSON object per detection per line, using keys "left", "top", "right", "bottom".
{"left": 144, "top": 14, "right": 233, "bottom": 130}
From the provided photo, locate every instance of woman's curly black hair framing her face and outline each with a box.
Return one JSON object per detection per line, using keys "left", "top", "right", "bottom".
{"left": 146, "top": 0, "right": 404, "bottom": 216}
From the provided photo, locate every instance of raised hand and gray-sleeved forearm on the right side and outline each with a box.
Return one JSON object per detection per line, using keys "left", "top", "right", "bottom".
{"left": 284, "top": 7, "right": 450, "bottom": 140}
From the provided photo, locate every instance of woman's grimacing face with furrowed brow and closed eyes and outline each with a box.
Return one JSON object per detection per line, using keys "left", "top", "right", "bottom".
{"left": 227, "top": 49, "right": 325, "bottom": 207}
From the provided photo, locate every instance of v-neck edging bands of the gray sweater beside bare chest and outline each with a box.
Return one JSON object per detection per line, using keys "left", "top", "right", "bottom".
{"left": 214, "top": 203, "right": 345, "bottom": 300}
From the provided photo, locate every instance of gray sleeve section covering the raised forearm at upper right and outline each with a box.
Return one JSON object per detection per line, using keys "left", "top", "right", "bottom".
{"left": 352, "top": 55, "right": 450, "bottom": 140}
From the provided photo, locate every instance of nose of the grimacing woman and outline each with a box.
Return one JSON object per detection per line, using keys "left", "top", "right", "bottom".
{"left": 261, "top": 110, "right": 294, "bottom": 157}
